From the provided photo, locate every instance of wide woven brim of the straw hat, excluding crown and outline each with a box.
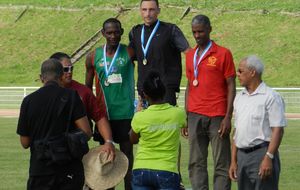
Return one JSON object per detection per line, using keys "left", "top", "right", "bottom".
{"left": 82, "top": 146, "right": 128, "bottom": 190}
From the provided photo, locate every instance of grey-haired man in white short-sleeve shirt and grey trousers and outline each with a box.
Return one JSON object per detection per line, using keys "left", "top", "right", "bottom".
{"left": 229, "top": 55, "right": 286, "bottom": 190}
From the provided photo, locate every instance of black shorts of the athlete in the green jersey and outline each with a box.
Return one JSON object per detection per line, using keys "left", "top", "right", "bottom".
{"left": 94, "top": 119, "right": 131, "bottom": 144}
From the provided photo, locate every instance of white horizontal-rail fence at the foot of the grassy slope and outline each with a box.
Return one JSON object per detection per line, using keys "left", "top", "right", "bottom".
{"left": 0, "top": 87, "right": 300, "bottom": 113}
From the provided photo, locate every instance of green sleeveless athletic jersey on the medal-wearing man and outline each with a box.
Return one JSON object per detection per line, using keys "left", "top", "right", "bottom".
{"left": 93, "top": 44, "right": 134, "bottom": 120}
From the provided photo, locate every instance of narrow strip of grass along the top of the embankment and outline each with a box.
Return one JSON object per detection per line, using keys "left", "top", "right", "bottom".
{"left": 0, "top": 0, "right": 300, "bottom": 12}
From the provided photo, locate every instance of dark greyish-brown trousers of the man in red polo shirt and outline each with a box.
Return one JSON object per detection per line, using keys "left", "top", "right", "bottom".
{"left": 188, "top": 113, "right": 231, "bottom": 190}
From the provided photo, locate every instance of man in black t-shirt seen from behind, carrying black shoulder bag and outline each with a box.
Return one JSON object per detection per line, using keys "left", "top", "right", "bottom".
{"left": 17, "top": 59, "right": 92, "bottom": 190}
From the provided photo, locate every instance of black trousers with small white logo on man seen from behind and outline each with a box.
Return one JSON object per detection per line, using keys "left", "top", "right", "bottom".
{"left": 27, "top": 172, "right": 84, "bottom": 190}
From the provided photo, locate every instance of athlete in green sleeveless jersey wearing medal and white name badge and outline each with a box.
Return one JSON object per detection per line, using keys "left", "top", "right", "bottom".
{"left": 85, "top": 18, "right": 134, "bottom": 190}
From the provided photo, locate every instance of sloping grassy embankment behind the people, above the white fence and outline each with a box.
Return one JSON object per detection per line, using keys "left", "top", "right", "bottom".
{"left": 0, "top": 0, "right": 300, "bottom": 87}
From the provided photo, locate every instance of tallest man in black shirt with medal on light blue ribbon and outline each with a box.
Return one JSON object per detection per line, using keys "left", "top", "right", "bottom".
{"left": 129, "top": 0, "right": 189, "bottom": 105}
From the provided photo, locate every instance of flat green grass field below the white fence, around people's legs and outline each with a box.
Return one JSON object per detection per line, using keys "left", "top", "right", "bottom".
{"left": 0, "top": 118, "right": 300, "bottom": 190}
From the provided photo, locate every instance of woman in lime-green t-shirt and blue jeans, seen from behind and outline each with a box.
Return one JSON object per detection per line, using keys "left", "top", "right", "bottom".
{"left": 129, "top": 71, "right": 186, "bottom": 190}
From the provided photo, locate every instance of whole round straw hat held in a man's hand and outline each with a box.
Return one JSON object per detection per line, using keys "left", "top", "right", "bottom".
{"left": 82, "top": 146, "right": 128, "bottom": 190}
